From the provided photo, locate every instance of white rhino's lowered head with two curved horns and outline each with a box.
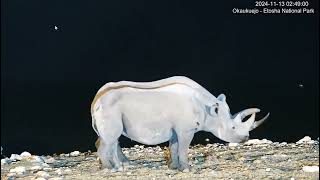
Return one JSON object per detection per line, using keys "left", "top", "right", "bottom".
{"left": 206, "top": 94, "right": 269, "bottom": 142}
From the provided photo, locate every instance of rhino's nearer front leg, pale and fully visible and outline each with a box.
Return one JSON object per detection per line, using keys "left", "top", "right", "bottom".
{"left": 177, "top": 132, "right": 194, "bottom": 172}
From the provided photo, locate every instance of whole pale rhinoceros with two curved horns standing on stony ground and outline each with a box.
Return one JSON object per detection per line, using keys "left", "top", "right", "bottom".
{"left": 91, "top": 76, "right": 269, "bottom": 171}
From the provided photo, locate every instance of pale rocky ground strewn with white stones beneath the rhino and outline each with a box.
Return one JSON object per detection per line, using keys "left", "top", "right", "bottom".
{"left": 1, "top": 137, "right": 319, "bottom": 180}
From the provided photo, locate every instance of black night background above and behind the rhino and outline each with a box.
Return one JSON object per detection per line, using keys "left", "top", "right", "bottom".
{"left": 1, "top": 0, "right": 319, "bottom": 154}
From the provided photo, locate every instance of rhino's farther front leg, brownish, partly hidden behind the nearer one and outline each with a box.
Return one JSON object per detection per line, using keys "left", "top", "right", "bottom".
{"left": 168, "top": 131, "right": 179, "bottom": 169}
